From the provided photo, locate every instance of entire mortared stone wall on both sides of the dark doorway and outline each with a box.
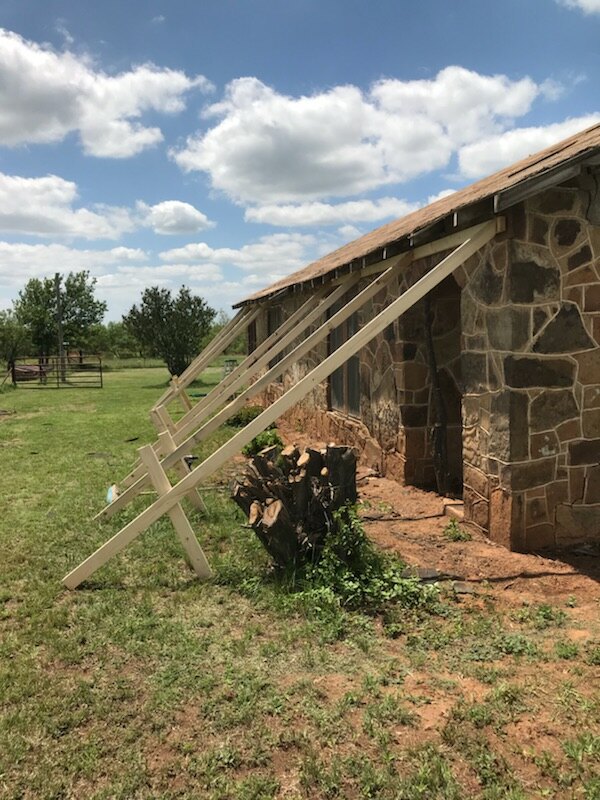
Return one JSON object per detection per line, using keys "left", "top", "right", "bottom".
{"left": 254, "top": 176, "right": 600, "bottom": 550}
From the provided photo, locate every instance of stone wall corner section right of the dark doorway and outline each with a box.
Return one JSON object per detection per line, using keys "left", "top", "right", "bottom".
{"left": 476, "top": 176, "right": 600, "bottom": 551}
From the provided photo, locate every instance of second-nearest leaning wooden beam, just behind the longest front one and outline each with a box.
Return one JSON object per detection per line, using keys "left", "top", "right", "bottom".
{"left": 94, "top": 262, "right": 398, "bottom": 519}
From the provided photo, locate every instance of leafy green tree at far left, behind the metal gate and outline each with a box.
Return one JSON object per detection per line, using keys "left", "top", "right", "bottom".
{"left": 14, "top": 271, "right": 106, "bottom": 356}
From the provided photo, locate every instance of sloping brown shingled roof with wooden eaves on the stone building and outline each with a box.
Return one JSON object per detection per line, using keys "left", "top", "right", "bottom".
{"left": 237, "top": 124, "right": 600, "bottom": 306}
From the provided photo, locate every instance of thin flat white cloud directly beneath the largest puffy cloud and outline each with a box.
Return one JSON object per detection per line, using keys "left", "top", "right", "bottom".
{"left": 244, "top": 197, "right": 419, "bottom": 227}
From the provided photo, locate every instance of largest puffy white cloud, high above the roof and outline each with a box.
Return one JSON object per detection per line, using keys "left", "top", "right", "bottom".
{"left": 171, "top": 66, "right": 557, "bottom": 206}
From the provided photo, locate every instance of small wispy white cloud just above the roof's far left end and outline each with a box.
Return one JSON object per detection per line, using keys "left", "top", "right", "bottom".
{"left": 160, "top": 233, "right": 315, "bottom": 276}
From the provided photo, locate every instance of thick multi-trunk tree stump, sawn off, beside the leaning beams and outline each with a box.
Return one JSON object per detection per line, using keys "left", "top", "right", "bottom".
{"left": 232, "top": 444, "right": 357, "bottom": 567}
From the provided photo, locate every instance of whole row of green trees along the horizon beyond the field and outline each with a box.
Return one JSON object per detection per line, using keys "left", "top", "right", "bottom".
{"left": 0, "top": 271, "right": 246, "bottom": 375}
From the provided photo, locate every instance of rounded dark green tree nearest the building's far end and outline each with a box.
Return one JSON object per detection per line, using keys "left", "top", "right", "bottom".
{"left": 123, "top": 286, "right": 216, "bottom": 375}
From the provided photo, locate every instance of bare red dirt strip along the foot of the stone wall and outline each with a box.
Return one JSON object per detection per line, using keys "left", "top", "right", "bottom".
{"left": 279, "top": 421, "right": 600, "bottom": 621}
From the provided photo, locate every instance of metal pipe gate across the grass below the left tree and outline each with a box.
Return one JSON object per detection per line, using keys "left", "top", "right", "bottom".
{"left": 11, "top": 355, "right": 103, "bottom": 389}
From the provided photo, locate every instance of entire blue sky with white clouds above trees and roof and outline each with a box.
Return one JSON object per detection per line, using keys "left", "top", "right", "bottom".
{"left": 0, "top": 0, "right": 600, "bottom": 319}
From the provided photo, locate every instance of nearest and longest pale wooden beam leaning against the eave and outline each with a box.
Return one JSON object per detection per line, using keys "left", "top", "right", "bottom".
{"left": 63, "top": 220, "right": 496, "bottom": 589}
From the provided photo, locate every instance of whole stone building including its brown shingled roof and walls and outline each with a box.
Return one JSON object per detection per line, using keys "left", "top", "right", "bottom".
{"left": 240, "top": 125, "right": 600, "bottom": 551}
